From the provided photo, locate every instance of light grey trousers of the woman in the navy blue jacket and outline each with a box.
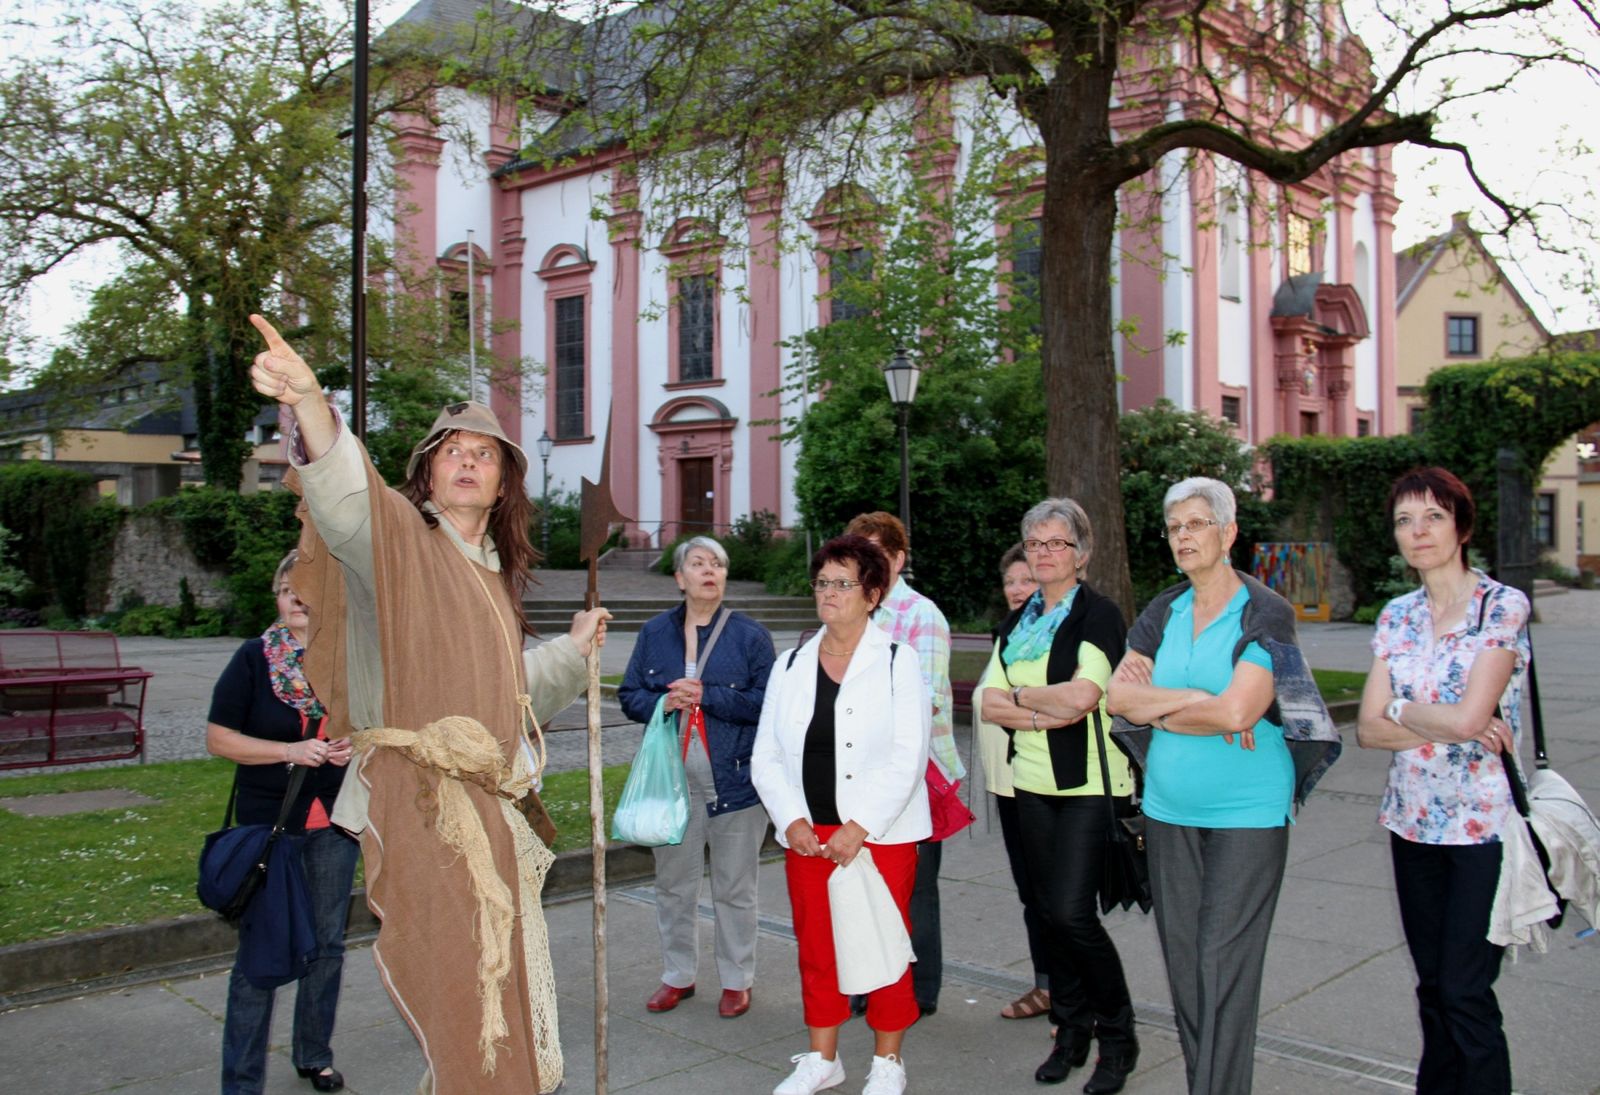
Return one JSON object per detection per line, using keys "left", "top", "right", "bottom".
{"left": 654, "top": 738, "right": 766, "bottom": 989}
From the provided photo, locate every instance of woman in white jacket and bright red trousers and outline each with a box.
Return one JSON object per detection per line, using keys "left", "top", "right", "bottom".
{"left": 750, "top": 536, "right": 933, "bottom": 1095}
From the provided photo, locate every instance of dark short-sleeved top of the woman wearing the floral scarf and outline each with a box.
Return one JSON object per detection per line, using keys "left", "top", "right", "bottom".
{"left": 206, "top": 639, "right": 344, "bottom": 832}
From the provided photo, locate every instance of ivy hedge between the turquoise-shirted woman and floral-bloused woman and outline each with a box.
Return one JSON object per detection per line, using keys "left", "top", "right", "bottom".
{"left": 1261, "top": 434, "right": 1429, "bottom": 605}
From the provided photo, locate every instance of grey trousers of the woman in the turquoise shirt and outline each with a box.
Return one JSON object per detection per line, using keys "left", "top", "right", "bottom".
{"left": 1146, "top": 818, "right": 1290, "bottom": 1095}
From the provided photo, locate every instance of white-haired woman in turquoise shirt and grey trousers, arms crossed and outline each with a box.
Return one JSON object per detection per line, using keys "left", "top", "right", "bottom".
{"left": 1109, "top": 479, "right": 1294, "bottom": 1095}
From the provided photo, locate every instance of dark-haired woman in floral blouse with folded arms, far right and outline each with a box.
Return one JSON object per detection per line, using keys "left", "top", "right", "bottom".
{"left": 1357, "top": 467, "right": 1530, "bottom": 1093}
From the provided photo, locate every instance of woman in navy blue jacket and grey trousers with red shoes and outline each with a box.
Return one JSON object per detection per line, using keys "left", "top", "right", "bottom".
{"left": 618, "top": 536, "right": 774, "bottom": 1018}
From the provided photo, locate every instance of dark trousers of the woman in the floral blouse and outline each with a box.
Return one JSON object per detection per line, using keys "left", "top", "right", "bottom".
{"left": 1389, "top": 832, "right": 1510, "bottom": 1095}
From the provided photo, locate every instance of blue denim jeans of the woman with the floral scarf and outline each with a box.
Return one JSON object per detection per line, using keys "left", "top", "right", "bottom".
{"left": 222, "top": 829, "right": 362, "bottom": 1095}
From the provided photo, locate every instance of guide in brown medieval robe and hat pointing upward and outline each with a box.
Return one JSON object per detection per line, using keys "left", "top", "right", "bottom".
{"left": 251, "top": 315, "right": 610, "bottom": 1095}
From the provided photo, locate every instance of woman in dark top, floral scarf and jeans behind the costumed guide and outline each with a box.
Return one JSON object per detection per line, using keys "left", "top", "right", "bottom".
{"left": 205, "top": 551, "right": 360, "bottom": 1095}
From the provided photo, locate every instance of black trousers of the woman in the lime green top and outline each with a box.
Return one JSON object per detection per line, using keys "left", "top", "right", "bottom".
{"left": 1016, "top": 789, "right": 1138, "bottom": 1053}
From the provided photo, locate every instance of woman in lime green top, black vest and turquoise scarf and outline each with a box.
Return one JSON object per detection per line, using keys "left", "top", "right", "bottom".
{"left": 981, "top": 498, "right": 1139, "bottom": 1095}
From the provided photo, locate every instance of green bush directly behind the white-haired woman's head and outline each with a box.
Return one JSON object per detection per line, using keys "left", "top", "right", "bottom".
{"left": 1120, "top": 399, "right": 1274, "bottom": 605}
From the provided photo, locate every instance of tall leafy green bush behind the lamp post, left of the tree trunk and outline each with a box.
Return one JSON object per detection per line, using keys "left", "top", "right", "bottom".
{"left": 786, "top": 129, "right": 1045, "bottom": 618}
